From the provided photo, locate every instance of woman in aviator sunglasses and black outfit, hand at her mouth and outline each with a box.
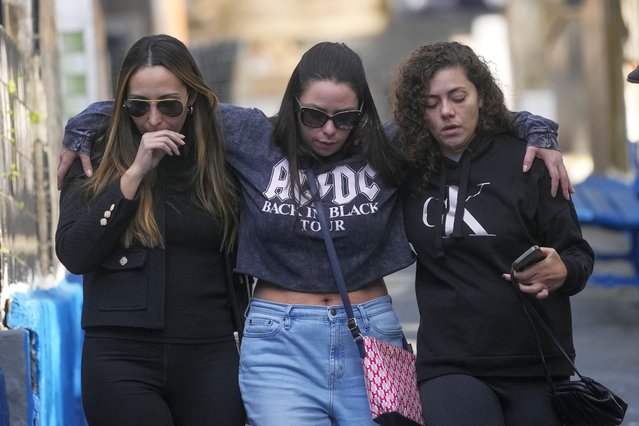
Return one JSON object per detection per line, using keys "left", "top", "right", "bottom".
{"left": 56, "top": 35, "right": 245, "bottom": 426}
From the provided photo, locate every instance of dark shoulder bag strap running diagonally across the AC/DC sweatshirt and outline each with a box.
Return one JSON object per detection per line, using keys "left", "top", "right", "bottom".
{"left": 305, "top": 169, "right": 366, "bottom": 358}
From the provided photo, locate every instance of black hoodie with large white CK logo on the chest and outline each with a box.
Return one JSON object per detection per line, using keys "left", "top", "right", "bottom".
{"left": 404, "top": 135, "right": 594, "bottom": 381}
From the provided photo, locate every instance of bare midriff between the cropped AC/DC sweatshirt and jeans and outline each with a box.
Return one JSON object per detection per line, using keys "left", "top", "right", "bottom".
{"left": 253, "top": 279, "right": 388, "bottom": 306}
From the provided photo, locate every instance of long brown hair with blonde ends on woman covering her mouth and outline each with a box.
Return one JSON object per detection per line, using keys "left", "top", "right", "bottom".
{"left": 88, "top": 35, "right": 240, "bottom": 251}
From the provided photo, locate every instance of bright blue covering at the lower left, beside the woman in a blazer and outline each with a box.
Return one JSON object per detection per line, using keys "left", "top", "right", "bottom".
{"left": 7, "top": 276, "right": 86, "bottom": 426}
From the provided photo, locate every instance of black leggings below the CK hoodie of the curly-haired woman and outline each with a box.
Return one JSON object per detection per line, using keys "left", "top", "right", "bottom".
{"left": 419, "top": 374, "right": 563, "bottom": 426}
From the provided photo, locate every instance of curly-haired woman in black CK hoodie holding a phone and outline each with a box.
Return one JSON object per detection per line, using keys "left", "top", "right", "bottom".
{"left": 393, "top": 42, "right": 593, "bottom": 426}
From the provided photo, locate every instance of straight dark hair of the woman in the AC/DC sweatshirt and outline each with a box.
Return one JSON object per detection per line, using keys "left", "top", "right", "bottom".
{"left": 273, "top": 42, "right": 401, "bottom": 195}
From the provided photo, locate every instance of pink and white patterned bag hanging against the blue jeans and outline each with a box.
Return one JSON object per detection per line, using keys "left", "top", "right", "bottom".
{"left": 362, "top": 336, "right": 424, "bottom": 425}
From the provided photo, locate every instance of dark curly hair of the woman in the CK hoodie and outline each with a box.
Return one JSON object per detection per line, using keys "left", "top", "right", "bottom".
{"left": 392, "top": 42, "right": 513, "bottom": 186}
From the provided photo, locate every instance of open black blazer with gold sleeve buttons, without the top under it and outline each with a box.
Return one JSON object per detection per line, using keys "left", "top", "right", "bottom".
{"left": 55, "top": 159, "right": 252, "bottom": 333}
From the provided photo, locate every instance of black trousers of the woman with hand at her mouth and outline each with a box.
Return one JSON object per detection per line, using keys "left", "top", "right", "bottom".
{"left": 82, "top": 337, "right": 245, "bottom": 426}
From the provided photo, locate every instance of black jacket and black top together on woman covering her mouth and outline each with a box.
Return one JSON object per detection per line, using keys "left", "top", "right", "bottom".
{"left": 56, "top": 141, "right": 237, "bottom": 343}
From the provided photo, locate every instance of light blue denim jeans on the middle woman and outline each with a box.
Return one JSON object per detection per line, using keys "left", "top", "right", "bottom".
{"left": 240, "top": 296, "right": 402, "bottom": 426}
